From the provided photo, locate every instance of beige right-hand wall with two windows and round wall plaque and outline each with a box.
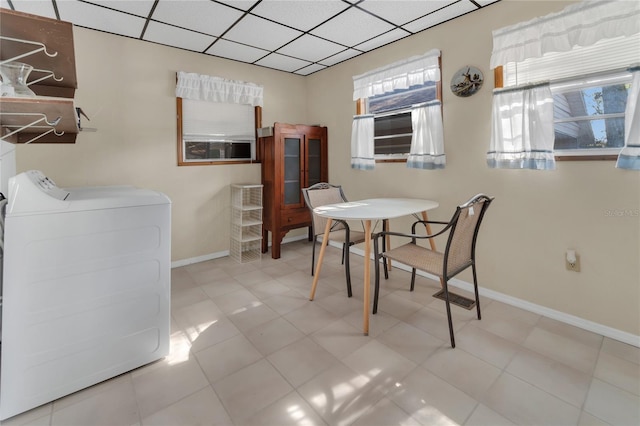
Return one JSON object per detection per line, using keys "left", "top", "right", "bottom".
{"left": 308, "top": 1, "right": 640, "bottom": 335}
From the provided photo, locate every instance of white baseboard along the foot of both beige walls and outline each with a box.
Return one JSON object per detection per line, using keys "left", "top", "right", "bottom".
{"left": 171, "top": 241, "right": 640, "bottom": 347}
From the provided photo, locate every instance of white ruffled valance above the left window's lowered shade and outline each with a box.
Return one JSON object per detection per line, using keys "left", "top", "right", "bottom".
{"left": 176, "top": 71, "right": 263, "bottom": 107}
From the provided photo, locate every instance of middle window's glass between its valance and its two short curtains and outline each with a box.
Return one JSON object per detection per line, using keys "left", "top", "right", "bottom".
{"left": 367, "top": 81, "right": 439, "bottom": 161}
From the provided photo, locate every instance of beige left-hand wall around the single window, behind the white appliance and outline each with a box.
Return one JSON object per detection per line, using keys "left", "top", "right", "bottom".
{"left": 17, "top": 27, "right": 307, "bottom": 261}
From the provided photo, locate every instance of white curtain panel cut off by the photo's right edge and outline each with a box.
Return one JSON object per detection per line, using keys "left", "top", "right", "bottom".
{"left": 616, "top": 68, "right": 640, "bottom": 170}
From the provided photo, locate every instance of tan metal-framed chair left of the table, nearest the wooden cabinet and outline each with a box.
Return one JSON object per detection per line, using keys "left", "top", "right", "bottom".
{"left": 302, "top": 182, "right": 364, "bottom": 297}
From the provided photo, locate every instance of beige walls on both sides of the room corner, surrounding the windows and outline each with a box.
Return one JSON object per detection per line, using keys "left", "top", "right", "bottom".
{"left": 17, "top": 0, "right": 640, "bottom": 335}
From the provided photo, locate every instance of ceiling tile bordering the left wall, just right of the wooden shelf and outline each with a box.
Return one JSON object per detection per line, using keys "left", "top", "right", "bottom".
{"left": 56, "top": 1, "right": 145, "bottom": 38}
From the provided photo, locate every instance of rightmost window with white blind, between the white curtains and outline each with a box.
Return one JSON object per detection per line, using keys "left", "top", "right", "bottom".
{"left": 492, "top": 3, "right": 640, "bottom": 160}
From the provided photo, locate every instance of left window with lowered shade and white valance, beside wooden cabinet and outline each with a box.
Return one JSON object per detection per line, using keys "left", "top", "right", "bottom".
{"left": 176, "top": 71, "right": 262, "bottom": 166}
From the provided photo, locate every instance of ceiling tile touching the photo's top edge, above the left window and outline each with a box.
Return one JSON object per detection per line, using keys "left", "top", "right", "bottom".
{"left": 151, "top": 0, "right": 243, "bottom": 37}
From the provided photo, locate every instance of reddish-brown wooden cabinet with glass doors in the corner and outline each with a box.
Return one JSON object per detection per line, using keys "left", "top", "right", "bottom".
{"left": 258, "top": 123, "right": 329, "bottom": 259}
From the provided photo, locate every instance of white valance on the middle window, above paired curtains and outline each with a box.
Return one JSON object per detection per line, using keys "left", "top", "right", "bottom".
{"left": 353, "top": 49, "right": 440, "bottom": 101}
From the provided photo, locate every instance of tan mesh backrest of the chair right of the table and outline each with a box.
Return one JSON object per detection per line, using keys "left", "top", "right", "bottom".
{"left": 445, "top": 194, "right": 493, "bottom": 276}
